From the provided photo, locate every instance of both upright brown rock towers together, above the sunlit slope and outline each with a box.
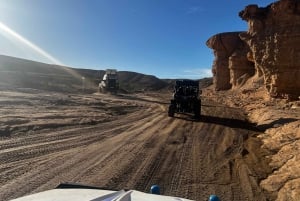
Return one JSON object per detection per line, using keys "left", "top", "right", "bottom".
{"left": 207, "top": 0, "right": 300, "bottom": 100}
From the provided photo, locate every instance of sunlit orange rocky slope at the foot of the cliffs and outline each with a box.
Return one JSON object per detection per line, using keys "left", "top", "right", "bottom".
{"left": 204, "top": 81, "right": 300, "bottom": 201}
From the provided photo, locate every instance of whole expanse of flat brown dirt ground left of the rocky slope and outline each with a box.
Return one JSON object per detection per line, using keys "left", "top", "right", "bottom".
{"left": 0, "top": 90, "right": 269, "bottom": 201}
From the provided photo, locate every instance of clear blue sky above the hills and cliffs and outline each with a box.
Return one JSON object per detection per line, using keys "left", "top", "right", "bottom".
{"left": 0, "top": 0, "right": 274, "bottom": 79}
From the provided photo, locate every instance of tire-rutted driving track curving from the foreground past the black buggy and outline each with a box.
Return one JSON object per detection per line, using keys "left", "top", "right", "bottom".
{"left": 0, "top": 92, "right": 270, "bottom": 201}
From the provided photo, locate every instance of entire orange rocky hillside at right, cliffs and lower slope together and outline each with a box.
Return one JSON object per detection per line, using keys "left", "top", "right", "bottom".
{"left": 204, "top": 0, "right": 300, "bottom": 201}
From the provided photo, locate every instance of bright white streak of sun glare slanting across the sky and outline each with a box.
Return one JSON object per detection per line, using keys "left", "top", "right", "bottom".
{"left": 0, "top": 22, "right": 63, "bottom": 65}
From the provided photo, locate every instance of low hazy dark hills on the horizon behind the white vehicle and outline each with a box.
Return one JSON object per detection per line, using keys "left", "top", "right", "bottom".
{"left": 0, "top": 55, "right": 210, "bottom": 93}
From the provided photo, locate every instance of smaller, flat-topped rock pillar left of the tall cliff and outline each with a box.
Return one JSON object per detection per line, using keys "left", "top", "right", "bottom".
{"left": 206, "top": 32, "right": 254, "bottom": 90}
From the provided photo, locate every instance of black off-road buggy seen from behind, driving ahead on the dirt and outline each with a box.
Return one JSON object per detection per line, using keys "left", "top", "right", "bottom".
{"left": 168, "top": 80, "right": 201, "bottom": 118}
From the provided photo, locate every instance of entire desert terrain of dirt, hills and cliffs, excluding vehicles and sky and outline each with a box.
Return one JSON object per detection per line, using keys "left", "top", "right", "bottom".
{"left": 0, "top": 0, "right": 300, "bottom": 201}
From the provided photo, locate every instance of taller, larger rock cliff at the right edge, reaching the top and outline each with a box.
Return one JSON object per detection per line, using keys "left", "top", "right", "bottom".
{"left": 239, "top": 0, "right": 300, "bottom": 100}
